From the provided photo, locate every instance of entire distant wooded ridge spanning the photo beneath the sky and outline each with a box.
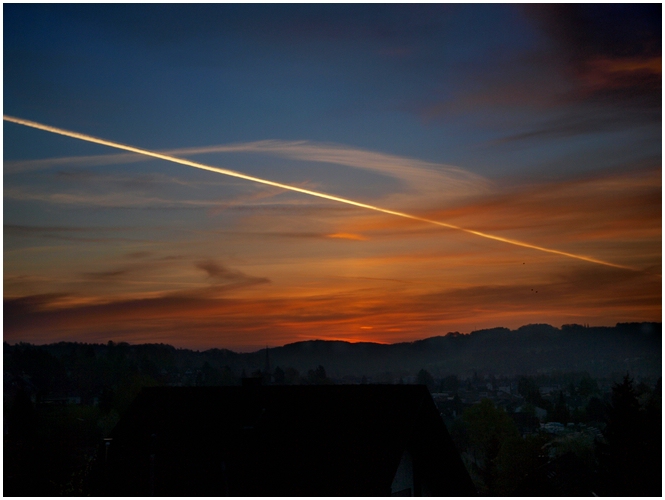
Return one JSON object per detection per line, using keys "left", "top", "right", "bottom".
{"left": 4, "top": 323, "right": 662, "bottom": 381}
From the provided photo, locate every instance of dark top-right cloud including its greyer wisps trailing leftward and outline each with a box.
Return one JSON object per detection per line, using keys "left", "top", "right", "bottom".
{"left": 414, "top": 4, "right": 662, "bottom": 145}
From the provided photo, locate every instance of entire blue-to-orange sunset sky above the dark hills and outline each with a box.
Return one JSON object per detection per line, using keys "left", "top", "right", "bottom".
{"left": 3, "top": 4, "right": 662, "bottom": 351}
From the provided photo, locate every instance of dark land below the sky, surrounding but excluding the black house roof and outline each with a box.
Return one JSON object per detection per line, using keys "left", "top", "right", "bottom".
{"left": 3, "top": 323, "right": 662, "bottom": 496}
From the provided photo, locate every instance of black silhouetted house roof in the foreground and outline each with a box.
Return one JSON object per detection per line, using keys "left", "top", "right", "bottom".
{"left": 97, "top": 385, "right": 475, "bottom": 496}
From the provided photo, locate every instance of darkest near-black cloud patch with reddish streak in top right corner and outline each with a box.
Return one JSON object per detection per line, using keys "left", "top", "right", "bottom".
{"left": 525, "top": 4, "right": 662, "bottom": 107}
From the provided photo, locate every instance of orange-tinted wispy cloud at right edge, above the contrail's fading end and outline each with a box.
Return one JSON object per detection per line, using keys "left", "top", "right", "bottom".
{"left": 426, "top": 168, "right": 662, "bottom": 241}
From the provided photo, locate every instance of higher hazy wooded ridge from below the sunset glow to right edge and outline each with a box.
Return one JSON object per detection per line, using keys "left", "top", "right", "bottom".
{"left": 253, "top": 323, "right": 662, "bottom": 377}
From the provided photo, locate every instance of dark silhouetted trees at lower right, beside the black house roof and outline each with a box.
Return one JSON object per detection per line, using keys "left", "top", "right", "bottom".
{"left": 447, "top": 375, "right": 662, "bottom": 497}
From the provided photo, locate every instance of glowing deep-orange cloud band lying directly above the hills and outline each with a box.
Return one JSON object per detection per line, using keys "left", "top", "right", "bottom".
{"left": 4, "top": 261, "right": 661, "bottom": 347}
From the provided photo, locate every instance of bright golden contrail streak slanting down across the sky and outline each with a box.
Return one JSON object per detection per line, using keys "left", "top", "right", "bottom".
{"left": 2, "top": 115, "right": 636, "bottom": 271}
